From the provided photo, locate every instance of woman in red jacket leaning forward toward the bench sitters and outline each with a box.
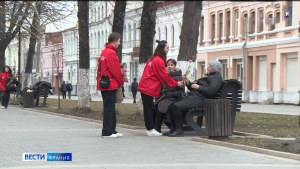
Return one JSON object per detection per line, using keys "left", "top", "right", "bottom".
{"left": 137, "top": 40, "right": 183, "bottom": 136}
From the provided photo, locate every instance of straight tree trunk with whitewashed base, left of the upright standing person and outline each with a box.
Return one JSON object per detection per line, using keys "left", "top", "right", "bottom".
{"left": 77, "top": 1, "right": 91, "bottom": 113}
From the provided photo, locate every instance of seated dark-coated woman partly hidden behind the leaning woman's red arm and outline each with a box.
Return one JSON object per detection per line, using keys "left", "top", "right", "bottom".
{"left": 154, "top": 59, "right": 184, "bottom": 133}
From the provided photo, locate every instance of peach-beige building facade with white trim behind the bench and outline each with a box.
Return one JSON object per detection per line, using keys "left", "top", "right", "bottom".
{"left": 196, "top": 1, "right": 300, "bottom": 104}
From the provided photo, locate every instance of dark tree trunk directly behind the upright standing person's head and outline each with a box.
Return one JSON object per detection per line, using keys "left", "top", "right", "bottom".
{"left": 112, "top": 1, "right": 126, "bottom": 63}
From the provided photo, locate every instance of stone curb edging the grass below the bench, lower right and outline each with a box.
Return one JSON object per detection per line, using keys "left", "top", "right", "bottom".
{"left": 192, "top": 138, "right": 300, "bottom": 160}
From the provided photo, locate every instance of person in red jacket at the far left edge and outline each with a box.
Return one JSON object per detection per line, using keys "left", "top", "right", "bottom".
{"left": 0, "top": 66, "right": 13, "bottom": 109}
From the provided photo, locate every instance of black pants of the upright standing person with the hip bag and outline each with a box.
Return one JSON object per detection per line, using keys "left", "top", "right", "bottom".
{"left": 101, "top": 90, "right": 117, "bottom": 136}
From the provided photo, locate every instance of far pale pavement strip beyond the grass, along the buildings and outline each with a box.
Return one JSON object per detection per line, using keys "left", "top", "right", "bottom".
{"left": 49, "top": 95, "right": 300, "bottom": 116}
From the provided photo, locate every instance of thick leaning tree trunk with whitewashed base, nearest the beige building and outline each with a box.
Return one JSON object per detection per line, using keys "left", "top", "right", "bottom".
{"left": 177, "top": 1, "right": 202, "bottom": 80}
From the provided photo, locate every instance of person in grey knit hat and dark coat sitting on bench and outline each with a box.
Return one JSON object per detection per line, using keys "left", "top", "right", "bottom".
{"left": 163, "top": 61, "right": 222, "bottom": 137}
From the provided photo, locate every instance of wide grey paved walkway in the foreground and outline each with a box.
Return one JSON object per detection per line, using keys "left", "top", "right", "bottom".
{"left": 0, "top": 107, "right": 300, "bottom": 169}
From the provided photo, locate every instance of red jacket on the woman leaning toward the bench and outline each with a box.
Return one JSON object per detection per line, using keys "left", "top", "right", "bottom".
{"left": 137, "top": 56, "right": 178, "bottom": 98}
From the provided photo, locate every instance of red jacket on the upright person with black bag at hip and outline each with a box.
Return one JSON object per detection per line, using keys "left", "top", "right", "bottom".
{"left": 97, "top": 45, "right": 124, "bottom": 91}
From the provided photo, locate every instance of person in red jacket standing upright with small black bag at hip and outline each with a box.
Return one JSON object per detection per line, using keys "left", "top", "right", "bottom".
{"left": 97, "top": 32, "right": 124, "bottom": 138}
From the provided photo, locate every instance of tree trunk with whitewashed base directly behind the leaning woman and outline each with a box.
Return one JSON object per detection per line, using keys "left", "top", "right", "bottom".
{"left": 130, "top": 1, "right": 157, "bottom": 119}
